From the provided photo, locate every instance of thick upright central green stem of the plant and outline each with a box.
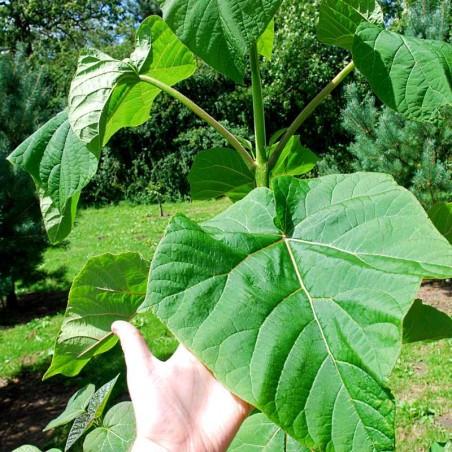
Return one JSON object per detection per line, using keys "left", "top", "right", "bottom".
{"left": 250, "top": 40, "right": 269, "bottom": 187}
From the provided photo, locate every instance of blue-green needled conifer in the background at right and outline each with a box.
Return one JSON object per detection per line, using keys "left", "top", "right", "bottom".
{"left": 319, "top": 0, "right": 452, "bottom": 208}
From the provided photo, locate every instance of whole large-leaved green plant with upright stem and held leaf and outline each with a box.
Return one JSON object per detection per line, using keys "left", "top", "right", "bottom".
{"left": 10, "top": 0, "right": 452, "bottom": 452}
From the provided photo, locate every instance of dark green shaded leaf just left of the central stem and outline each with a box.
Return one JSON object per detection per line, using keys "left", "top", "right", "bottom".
{"left": 188, "top": 148, "right": 256, "bottom": 201}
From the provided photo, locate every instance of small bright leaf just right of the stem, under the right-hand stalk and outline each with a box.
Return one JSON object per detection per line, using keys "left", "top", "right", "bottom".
{"left": 271, "top": 135, "right": 319, "bottom": 177}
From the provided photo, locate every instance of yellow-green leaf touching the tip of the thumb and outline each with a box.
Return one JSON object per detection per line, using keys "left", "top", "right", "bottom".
{"left": 44, "top": 253, "right": 149, "bottom": 378}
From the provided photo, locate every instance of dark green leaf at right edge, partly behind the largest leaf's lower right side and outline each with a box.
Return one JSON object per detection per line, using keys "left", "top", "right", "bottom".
{"left": 403, "top": 300, "right": 452, "bottom": 343}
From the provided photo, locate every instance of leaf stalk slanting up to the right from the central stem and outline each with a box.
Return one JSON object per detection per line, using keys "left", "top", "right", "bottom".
{"left": 268, "top": 62, "right": 355, "bottom": 169}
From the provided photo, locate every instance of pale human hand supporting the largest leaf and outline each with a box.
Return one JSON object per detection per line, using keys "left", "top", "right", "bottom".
{"left": 112, "top": 321, "right": 250, "bottom": 452}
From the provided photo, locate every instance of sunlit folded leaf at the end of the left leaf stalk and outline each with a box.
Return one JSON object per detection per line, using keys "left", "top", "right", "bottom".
{"left": 69, "top": 16, "right": 196, "bottom": 152}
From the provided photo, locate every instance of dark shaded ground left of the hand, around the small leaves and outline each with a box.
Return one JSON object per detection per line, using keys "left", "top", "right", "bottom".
{"left": 0, "top": 346, "right": 128, "bottom": 452}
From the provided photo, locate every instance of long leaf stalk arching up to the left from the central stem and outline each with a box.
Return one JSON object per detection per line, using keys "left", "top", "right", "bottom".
{"left": 139, "top": 75, "right": 256, "bottom": 169}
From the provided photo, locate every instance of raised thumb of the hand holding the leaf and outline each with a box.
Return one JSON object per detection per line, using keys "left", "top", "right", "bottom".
{"left": 111, "top": 321, "right": 157, "bottom": 377}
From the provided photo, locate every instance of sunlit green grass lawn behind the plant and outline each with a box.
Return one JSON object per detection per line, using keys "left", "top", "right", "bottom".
{"left": 0, "top": 201, "right": 452, "bottom": 452}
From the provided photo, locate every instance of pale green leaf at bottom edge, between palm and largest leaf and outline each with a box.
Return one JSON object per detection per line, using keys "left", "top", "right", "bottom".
{"left": 228, "top": 413, "right": 309, "bottom": 452}
